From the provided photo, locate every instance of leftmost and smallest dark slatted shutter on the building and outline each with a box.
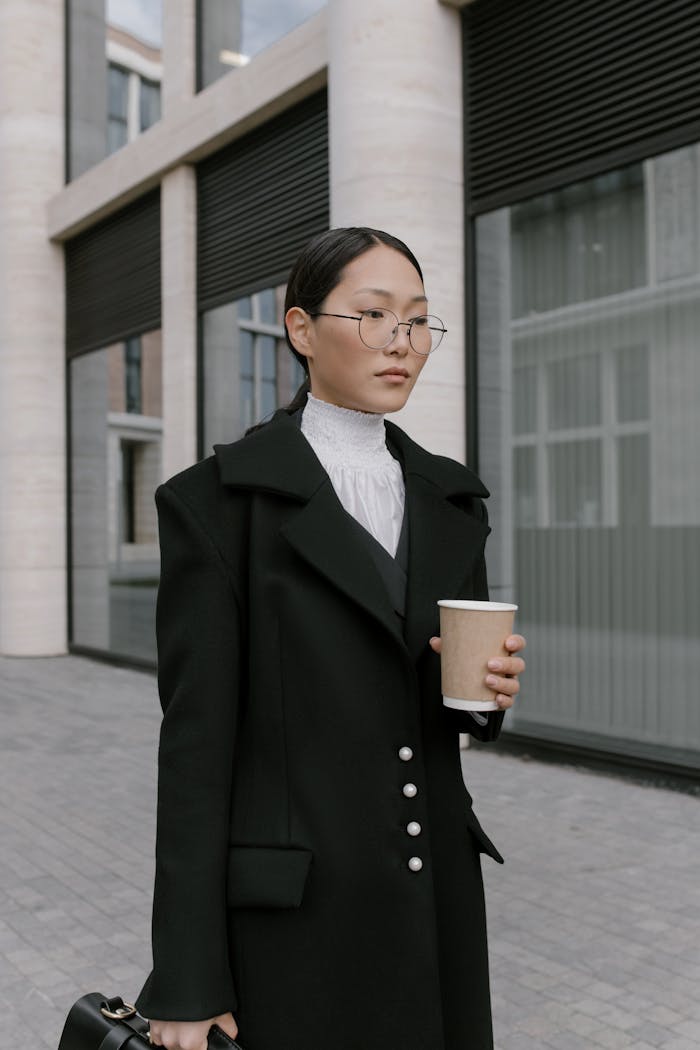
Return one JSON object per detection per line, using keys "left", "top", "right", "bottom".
{"left": 65, "top": 190, "right": 161, "bottom": 357}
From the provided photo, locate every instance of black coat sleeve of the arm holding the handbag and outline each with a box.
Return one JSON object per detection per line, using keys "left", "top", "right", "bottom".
{"left": 135, "top": 483, "right": 240, "bottom": 1021}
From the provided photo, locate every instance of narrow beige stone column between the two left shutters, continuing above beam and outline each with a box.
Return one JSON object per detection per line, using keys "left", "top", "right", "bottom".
{"left": 161, "top": 0, "right": 197, "bottom": 479}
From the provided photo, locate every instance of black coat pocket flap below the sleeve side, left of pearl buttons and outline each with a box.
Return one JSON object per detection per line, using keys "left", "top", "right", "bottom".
{"left": 227, "top": 846, "right": 313, "bottom": 908}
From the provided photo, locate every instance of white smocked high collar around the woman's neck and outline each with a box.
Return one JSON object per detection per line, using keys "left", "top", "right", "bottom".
{"left": 301, "top": 394, "right": 395, "bottom": 469}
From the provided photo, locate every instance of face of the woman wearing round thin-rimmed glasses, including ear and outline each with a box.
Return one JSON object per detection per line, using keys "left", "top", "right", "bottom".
{"left": 287, "top": 245, "right": 428, "bottom": 413}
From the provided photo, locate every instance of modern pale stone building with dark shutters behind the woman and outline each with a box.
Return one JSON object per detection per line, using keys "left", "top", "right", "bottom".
{"left": 0, "top": 0, "right": 700, "bottom": 772}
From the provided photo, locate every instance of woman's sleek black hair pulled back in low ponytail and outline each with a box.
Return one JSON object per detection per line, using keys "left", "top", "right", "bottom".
{"left": 246, "top": 226, "right": 423, "bottom": 434}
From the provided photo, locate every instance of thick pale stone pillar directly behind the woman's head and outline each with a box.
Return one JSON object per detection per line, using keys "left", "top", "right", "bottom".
{"left": 328, "top": 0, "right": 465, "bottom": 461}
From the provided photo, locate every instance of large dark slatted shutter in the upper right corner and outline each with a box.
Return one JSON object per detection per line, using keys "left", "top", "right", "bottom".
{"left": 463, "top": 0, "right": 700, "bottom": 213}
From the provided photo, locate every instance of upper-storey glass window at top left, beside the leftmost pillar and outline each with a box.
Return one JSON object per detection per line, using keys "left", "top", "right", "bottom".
{"left": 66, "top": 0, "right": 163, "bottom": 180}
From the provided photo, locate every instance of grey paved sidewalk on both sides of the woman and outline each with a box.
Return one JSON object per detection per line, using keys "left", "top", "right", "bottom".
{"left": 0, "top": 656, "right": 700, "bottom": 1050}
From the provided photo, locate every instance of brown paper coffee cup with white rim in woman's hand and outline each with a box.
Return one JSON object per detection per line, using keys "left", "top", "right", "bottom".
{"left": 438, "top": 599, "right": 517, "bottom": 711}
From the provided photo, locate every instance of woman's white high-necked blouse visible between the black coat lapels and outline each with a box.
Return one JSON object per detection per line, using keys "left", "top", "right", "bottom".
{"left": 301, "top": 394, "right": 405, "bottom": 557}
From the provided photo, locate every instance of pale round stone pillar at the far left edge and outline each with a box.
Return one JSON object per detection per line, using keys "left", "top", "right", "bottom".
{"left": 0, "top": 0, "right": 66, "bottom": 656}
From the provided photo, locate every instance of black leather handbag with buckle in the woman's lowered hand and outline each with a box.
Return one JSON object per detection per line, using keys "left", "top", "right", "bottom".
{"left": 59, "top": 991, "right": 242, "bottom": 1050}
